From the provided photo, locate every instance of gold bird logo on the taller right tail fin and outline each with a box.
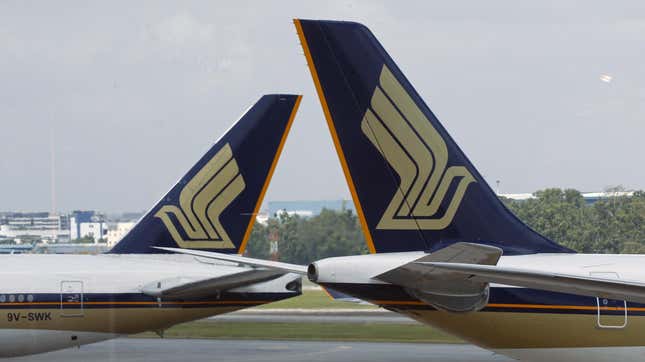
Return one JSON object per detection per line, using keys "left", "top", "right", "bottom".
{"left": 361, "top": 65, "right": 475, "bottom": 230}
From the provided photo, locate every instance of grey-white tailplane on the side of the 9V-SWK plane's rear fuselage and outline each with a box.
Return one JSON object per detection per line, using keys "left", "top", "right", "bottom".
{"left": 141, "top": 269, "right": 284, "bottom": 298}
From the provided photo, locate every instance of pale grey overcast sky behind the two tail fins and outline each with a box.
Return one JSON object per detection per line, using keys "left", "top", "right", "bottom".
{"left": 0, "top": 0, "right": 645, "bottom": 211}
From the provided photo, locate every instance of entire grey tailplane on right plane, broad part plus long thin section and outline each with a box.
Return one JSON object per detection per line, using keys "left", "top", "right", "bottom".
{"left": 374, "top": 242, "right": 645, "bottom": 311}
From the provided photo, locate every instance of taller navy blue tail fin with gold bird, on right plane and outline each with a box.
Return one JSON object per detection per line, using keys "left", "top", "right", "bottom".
{"left": 295, "top": 20, "right": 571, "bottom": 254}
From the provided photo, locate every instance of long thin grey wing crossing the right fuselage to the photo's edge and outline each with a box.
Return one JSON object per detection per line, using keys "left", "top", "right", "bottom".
{"left": 417, "top": 261, "right": 645, "bottom": 303}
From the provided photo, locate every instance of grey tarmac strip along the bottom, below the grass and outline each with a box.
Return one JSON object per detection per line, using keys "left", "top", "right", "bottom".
{"left": 9, "top": 338, "right": 512, "bottom": 362}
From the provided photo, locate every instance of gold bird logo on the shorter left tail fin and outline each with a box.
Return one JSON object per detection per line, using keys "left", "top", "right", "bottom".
{"left": 155, "top": 143, "right": 246, "bottom": 249}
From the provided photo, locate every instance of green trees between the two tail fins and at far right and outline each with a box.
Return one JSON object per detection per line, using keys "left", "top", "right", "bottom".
{"left": 247, "top": 188, "right": 645, "bottom": 264}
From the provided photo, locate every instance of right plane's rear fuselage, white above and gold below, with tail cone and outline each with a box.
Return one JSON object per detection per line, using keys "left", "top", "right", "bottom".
{"left": 314, "top": 252, "right": 645, "bottom": 361}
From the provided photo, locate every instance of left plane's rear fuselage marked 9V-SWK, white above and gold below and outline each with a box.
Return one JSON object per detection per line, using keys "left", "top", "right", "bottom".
{"left": 0, "top": 254, "right": 299, "bottom": 357}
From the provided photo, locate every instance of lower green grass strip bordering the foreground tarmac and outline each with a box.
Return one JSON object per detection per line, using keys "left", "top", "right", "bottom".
{"left": 135, "top": 320, "right": 461, "bottom": 343}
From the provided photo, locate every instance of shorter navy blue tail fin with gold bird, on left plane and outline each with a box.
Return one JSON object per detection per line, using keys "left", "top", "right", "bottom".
{"left": 110, "top": 94, "right": 301, "bottom": 254}
